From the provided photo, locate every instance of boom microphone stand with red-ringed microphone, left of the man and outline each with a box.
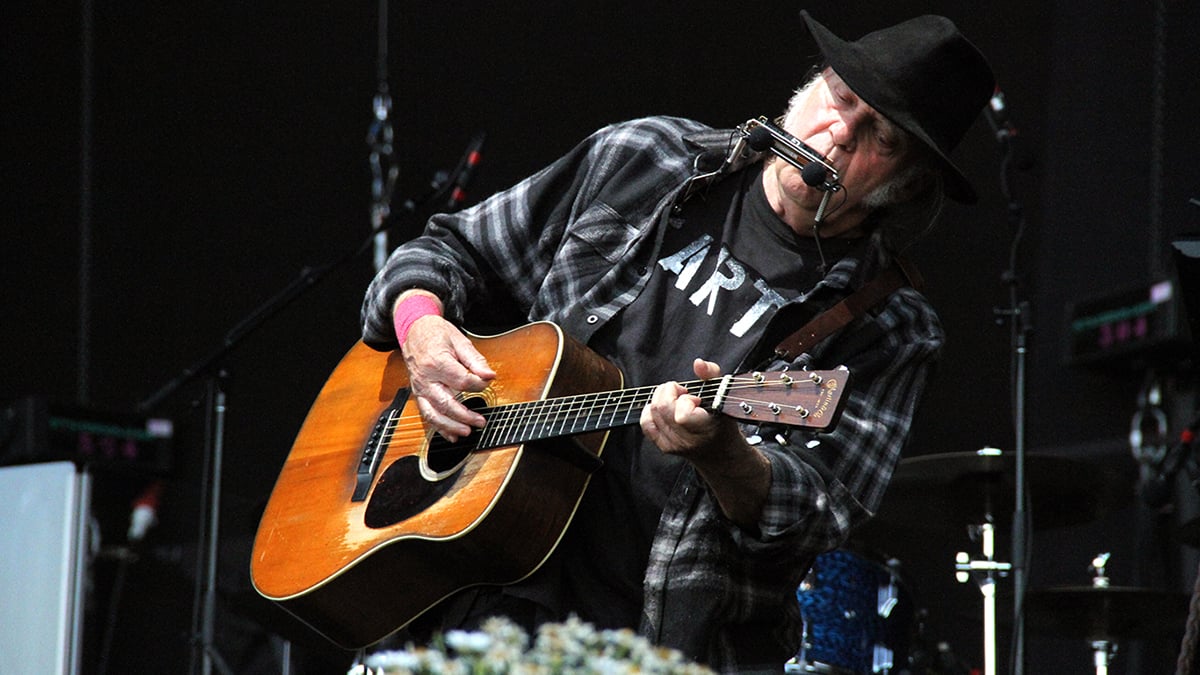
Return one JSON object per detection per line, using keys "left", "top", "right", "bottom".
{"left": 137, "top": 172, "right": 452, "bottom": 675}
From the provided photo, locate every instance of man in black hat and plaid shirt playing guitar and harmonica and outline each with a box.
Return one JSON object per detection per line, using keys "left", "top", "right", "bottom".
{"left": 362, "top": 13, "right": 994, "bottom": 673}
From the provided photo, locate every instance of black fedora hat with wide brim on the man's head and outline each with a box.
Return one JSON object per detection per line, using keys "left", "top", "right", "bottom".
{"left": 800, "top": 11, "right": 996, "bottom": 204}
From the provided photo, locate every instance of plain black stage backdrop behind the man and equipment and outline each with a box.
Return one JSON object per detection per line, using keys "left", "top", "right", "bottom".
{"left": 0, "top": 0, "right": 1200, "bottom": 671}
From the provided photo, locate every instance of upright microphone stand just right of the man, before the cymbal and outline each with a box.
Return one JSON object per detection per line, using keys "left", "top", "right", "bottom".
{"left": 988, "top": 106, "right": 1033, "bottom": 675}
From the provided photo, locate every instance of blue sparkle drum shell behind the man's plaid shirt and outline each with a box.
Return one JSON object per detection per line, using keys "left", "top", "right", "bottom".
{"left": 796, "top": 549, "right": 916, "bottom": 675}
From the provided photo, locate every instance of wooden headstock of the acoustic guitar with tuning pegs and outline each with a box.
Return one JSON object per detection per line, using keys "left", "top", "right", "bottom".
{"left": 714, "top": 366, "right": 850, "bottom": 430}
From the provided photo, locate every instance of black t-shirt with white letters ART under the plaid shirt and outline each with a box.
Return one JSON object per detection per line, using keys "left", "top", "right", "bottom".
{"left": 540, "top": 169, "right": 853, "bottom": 627}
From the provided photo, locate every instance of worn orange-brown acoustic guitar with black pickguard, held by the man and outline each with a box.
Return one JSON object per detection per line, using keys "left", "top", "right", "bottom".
{"left": 251, "top": 323, "right": 850, "bottom": 649}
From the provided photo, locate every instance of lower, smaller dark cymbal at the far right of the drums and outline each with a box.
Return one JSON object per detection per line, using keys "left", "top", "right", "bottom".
{"left": 1025, "top": 586, "right": 1188, "bottom": 641}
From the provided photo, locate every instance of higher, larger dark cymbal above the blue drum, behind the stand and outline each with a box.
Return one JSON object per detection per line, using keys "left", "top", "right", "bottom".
{"left": 859, "top": 452, "right": 1133, "bottom": 531}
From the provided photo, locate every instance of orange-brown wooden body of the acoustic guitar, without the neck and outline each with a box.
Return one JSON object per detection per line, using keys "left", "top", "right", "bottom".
{"left": 251, "top": 323, "right": 622, "bottom": 649}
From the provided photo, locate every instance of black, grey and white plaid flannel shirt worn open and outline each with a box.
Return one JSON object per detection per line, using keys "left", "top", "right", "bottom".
{"left": 362, "top": 118, "right": 943, "bottom": 673}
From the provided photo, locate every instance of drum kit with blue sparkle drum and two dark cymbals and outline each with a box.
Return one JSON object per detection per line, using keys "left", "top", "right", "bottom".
{"left": 785, "top": 448, "right": 1189, "bottom": 675}
